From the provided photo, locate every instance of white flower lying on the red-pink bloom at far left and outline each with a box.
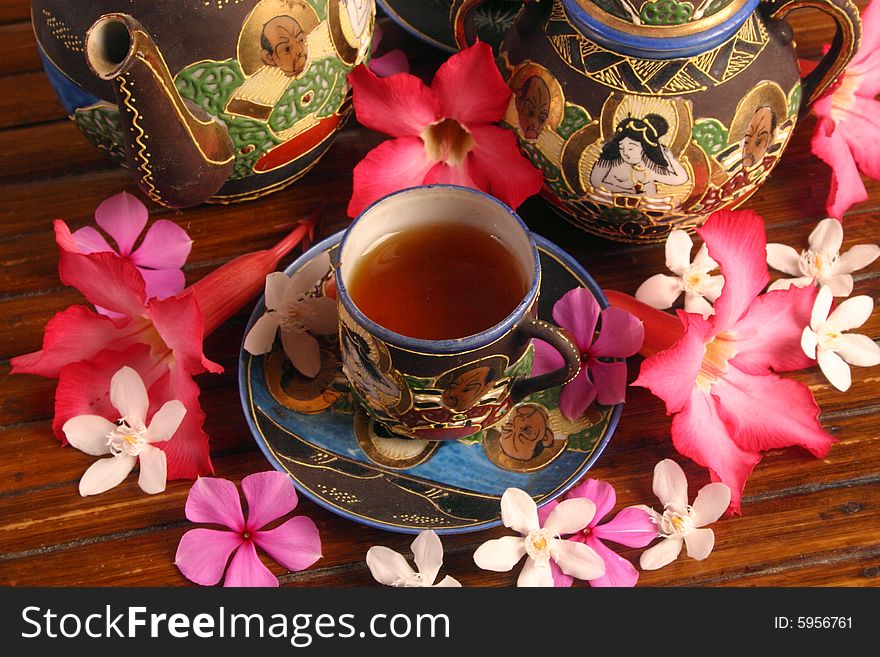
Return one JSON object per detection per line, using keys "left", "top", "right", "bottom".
{"left": 61, "top": 367, "right": 186, "bottom": 497}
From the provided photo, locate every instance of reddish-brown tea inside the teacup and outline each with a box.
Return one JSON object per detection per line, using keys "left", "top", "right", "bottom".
{"left": 348, "top": 224, "right": 530, "bottom": 340}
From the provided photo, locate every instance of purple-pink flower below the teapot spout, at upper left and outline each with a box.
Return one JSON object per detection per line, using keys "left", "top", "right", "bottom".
{"left": 72, "top": 192, "right": 192, "bottom": 312}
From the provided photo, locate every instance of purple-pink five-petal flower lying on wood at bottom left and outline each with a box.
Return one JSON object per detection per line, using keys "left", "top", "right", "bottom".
{"left": 175, "top": 471, "right": 321, "bottom": 586}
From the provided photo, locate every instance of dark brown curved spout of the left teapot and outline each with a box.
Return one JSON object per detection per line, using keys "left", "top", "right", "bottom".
{"left": 85, "top": 13, "right": 235, "bottom": 208}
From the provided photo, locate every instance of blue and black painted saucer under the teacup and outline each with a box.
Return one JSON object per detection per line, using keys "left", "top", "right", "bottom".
{"left": 238, "top": 232, "right": 622, "bottom": 534}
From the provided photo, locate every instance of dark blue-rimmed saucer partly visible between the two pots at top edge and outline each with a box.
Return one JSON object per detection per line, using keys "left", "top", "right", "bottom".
{"left": 376, "top": 0, "right": 522, "bottom": 52}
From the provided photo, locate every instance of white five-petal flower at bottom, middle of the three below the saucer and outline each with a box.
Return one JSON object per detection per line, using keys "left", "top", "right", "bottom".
{"left": 474, "top": 488, "right": 605, "bottom": 586}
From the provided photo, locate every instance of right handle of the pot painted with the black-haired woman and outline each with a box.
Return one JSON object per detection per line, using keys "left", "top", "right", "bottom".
{"left": 761, "top": 0, "right": 862, "bottom": 110}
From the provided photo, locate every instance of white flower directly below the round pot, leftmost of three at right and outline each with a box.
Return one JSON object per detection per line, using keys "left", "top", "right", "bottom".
{"left": 636, "top": 230, "right": 724, "bottom": 319}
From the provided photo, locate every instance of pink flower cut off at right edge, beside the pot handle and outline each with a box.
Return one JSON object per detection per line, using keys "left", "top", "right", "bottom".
{"left": 811, "top": 0, "right": 880, "bottom": 219}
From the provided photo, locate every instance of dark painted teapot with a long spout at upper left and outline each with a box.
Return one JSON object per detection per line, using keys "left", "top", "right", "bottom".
{"left": 31, "top": 0, "right": 376, "bottom": 208}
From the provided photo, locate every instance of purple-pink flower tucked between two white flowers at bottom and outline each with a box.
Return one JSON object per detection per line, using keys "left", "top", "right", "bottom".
{"left": 538, "top": 479, "right": 657, "bottom": 587}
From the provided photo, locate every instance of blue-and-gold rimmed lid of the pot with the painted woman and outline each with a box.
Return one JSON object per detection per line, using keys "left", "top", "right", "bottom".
{"left": 562, "top": 0, "right": 760, "bottom": 59}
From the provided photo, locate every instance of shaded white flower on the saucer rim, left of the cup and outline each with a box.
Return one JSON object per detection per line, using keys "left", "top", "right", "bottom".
{"left": 244, "top": 252, "right": 338, "bottom": 378}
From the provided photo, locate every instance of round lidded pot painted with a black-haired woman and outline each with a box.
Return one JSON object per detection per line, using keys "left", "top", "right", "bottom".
{"left": 450, "top": 0, "right": 861, "bottom": 242}
